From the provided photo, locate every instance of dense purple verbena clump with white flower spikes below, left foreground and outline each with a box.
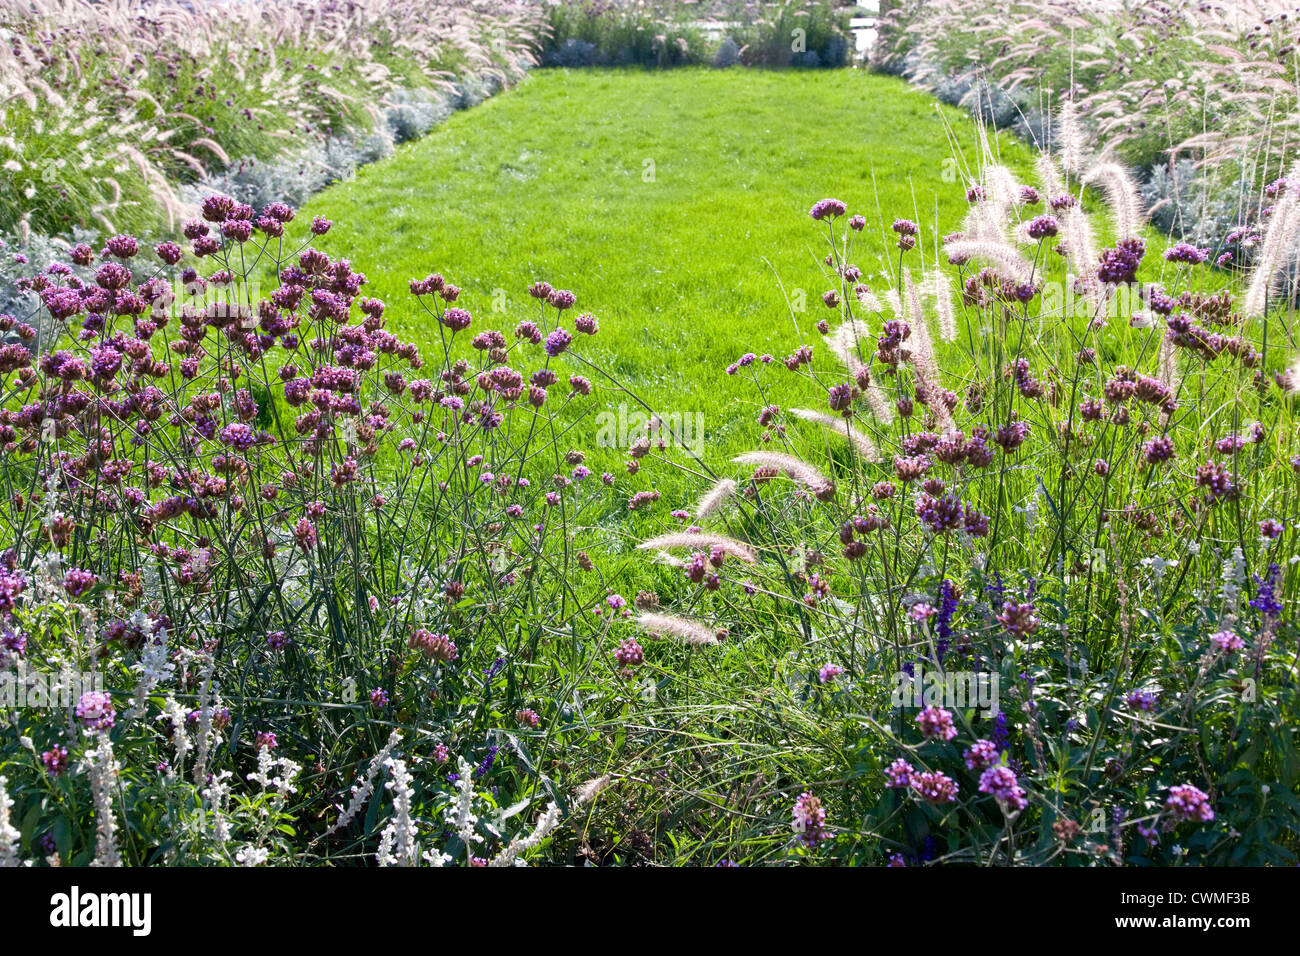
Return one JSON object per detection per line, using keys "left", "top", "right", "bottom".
{"left": 0, "top": 196, "right": 634, "bottom": 865}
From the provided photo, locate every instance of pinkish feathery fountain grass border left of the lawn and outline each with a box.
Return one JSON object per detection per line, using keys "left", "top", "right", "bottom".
{"left": 0, "top": 0, "right": 543, "bottom": 235}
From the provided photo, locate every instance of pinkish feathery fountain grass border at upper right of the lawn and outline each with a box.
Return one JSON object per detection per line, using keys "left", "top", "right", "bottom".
{"left": 874, "top": 0, "right": 1300, "bottom": 257}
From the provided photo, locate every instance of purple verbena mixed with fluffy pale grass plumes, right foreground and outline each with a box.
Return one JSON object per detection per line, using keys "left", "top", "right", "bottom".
{"left": 603, "top": 141, "right": 1300, "bottom": 866}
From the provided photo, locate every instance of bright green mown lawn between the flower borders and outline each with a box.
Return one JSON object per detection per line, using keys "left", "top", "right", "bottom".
{"left": 307, "top": 69, "right": 1030, "bottom": 522}
